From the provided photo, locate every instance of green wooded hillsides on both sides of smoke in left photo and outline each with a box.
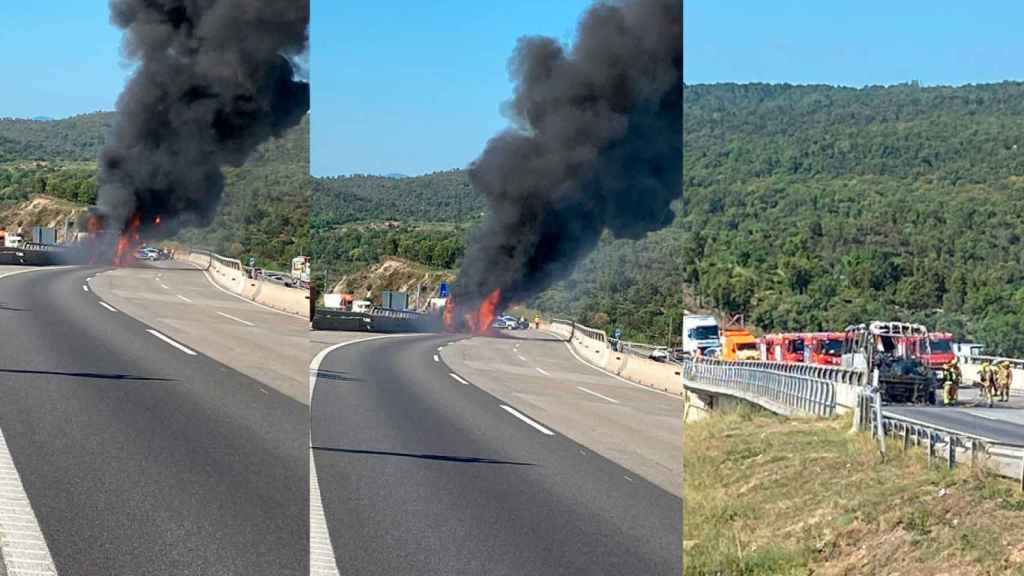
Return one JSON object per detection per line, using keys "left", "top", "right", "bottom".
{"left": 0, "top": 113, "right": 311, "bottom": 269}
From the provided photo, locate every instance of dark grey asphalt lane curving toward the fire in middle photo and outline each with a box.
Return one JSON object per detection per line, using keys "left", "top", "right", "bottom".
{"left": 310, "top": 335, "right": 682, "bottom": 576}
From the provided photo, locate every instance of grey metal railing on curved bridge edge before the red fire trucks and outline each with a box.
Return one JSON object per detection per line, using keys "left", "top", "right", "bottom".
{"left": 680, "top": 359, "right": 851, "bottom": 416}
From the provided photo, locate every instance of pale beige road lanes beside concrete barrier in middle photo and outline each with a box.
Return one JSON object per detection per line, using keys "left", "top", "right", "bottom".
{"left": 441, "top": 330, "right": 683, "bottom": 497}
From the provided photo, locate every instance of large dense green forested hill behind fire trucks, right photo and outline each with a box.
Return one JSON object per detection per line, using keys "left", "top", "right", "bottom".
{"left": 674, "top": 83, "right": 1024, "bottom": 354}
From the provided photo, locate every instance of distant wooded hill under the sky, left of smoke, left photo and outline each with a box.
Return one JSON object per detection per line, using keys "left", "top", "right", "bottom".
{"left": 0, "top": 112, "right": 114, "bottom": 163}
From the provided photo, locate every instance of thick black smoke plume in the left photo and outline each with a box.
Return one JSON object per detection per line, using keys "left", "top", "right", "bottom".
{"left": 98, "top": 0, "right": 309, "bottom": 237}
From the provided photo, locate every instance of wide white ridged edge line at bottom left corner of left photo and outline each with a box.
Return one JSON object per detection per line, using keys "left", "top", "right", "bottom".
{"left": 0, "top": 424, "right": 57, "bottom": 576}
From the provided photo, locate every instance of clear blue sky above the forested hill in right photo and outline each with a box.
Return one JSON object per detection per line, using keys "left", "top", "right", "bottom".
{"left": 683, "top": 0, "right": 1024, "bottom": 87}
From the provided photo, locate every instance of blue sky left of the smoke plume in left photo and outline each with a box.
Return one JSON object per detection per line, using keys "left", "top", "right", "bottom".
{"left": 0, "top": 0, "right": 129, "bottom": 118}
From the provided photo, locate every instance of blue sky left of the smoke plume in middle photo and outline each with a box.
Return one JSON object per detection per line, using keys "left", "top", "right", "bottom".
{"left": 310, "top": 0, "right": 591, "bottom": 176}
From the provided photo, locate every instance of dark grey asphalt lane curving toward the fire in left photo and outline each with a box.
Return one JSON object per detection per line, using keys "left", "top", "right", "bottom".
{"left": 0, "top": 266, "right": 308, "bottom": 575}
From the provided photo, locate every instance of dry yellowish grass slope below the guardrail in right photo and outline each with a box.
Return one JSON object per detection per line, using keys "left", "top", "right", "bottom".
{"left": 684, "top": 411, "right": 1024, "bottom": 576}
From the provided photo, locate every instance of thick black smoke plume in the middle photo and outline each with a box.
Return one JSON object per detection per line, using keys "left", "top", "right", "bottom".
{"left": 453, "top": 0, "right": 683, "bottom": 311}
